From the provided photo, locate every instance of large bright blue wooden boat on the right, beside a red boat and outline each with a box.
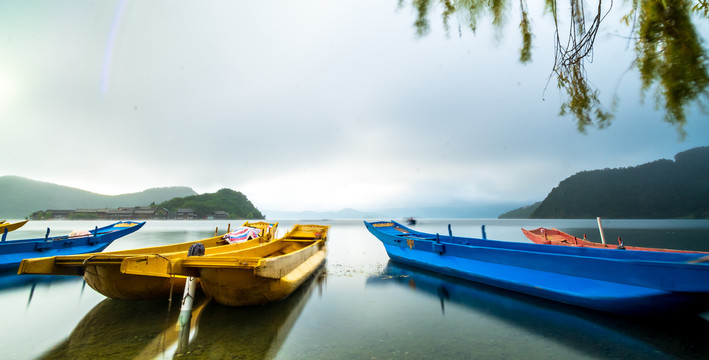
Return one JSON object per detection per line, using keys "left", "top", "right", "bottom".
{"left": 365, "top": 221, "right": 709, "bottom": 315}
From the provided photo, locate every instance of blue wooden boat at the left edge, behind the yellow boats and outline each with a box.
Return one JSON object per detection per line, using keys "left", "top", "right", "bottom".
{"left": 0, "top": 221, "right": 145, "bottom": 270}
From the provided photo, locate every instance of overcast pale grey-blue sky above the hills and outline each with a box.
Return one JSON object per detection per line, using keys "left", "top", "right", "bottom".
{"left": 0, "top": 0, "right": 709, "bottom": 211}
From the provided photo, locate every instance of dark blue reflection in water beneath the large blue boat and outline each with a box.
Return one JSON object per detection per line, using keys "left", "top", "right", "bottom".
{"left": 367, "top": 261, "right": 709, "bottom": 359}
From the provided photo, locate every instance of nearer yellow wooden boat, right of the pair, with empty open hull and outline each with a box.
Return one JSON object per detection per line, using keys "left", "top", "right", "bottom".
{"left": 121, "top": 225, "right": 329, "bottom": 306}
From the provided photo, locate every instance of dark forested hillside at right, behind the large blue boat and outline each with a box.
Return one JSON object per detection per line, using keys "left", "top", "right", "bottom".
{"left": 531, "top": 147, "right": 709, "bottom": 219}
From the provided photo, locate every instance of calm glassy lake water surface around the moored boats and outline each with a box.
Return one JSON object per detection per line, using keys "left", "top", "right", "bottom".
{"left": 0, "top": 219, "right": 709, "bottom": 359}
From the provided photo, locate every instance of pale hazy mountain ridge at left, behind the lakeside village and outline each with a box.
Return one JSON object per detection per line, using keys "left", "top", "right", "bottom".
{"left": 0, "top": 176, "right": 197, "bottom": 219}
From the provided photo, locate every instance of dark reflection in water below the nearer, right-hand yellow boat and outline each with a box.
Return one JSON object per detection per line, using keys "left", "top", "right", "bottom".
{"left": 175, "top": 266, "right": 325, "bottom": 360}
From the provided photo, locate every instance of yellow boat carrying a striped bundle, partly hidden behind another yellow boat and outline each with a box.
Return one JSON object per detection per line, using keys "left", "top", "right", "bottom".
{"left": 18, "top": 221, "right": 278, "bottom": 300}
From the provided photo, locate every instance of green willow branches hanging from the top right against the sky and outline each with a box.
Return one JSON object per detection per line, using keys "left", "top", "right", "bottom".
{"left": 399, "top": 0, "right": 709, "bottom": 137}
